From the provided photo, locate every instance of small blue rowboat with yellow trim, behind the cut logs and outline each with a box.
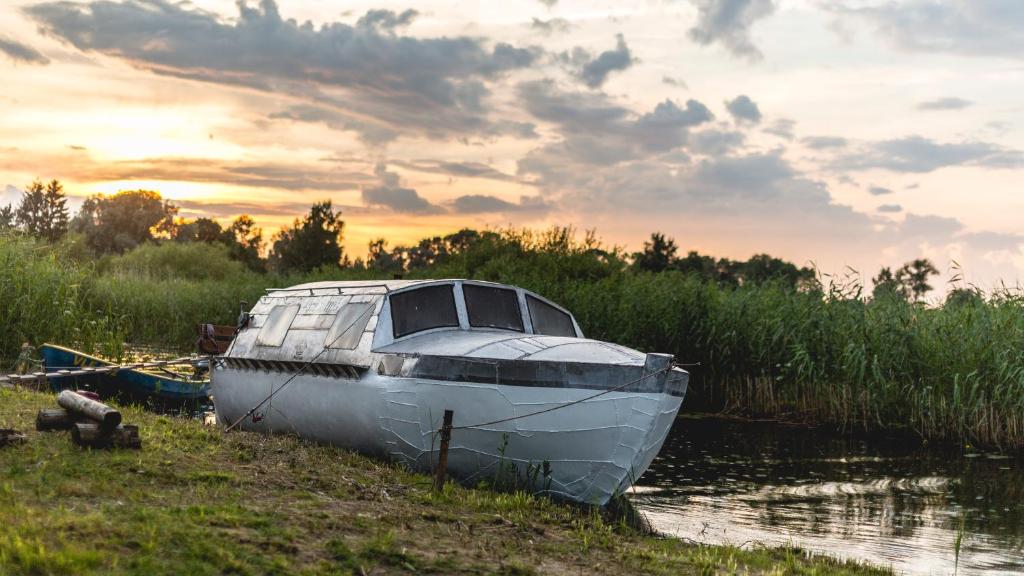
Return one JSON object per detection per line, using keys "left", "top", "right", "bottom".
{"left": 39, "top": 344, "right": 210, "bottom": 402}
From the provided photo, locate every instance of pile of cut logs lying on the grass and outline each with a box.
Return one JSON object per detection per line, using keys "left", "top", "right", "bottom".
{"left": 36, "top": 390, "right": 142, "bottom": 449}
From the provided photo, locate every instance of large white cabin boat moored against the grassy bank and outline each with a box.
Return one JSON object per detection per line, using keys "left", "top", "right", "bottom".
{"left": 211, "top": 280, "right": 689, "bottom": 505}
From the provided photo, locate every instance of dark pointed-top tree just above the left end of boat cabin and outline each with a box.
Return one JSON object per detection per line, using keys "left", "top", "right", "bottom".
{"left": 270, "top": 200, "right": 345, "bottom": 272}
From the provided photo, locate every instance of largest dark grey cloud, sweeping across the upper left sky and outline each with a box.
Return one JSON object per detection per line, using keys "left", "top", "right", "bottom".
{"left": 25, "top": 0, "right": 541, "bottom": 143}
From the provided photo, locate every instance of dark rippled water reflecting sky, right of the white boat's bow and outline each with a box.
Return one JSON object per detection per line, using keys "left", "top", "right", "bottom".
{"left": 633, "top": 418, "right": 1024, "bottom": 575}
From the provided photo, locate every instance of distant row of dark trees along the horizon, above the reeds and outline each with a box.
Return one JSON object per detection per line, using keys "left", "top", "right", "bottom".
{"left": 0, "top": 180, "right": 942, "bottom": 301}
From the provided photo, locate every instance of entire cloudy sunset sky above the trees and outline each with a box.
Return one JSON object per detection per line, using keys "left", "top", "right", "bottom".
{"left": 0, "top": 0, "right": 1024, "bottom": 291}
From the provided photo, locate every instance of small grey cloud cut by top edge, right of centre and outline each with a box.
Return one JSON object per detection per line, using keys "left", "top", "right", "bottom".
{"left": 689, "top": 0, "right": 775, "bottom": 60}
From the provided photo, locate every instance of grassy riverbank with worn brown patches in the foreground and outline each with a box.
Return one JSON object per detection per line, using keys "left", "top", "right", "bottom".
{"left": 0, "top": 390, "right": 888, "bottom": 575}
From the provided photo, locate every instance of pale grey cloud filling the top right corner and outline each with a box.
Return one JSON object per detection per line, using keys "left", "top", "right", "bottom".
{"left": 822, "top": 0, "right": 1024, "bottom": 59}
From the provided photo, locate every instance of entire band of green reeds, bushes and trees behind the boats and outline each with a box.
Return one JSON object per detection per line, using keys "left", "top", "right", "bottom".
{"left": 0, "top": 181, "right": 1024, "bottom": 449}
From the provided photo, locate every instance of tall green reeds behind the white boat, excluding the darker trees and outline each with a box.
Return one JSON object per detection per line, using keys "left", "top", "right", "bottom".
{"left": 0, "top": 231, "right": 1024, "bottom": 450}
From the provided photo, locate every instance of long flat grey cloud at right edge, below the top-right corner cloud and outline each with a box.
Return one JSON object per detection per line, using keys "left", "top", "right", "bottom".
{"left": 833, "top": 135, "right": 1024, "bottom": 173}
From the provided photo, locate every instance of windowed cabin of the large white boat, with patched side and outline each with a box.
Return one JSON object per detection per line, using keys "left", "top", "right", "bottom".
{"left": 226, "top": 280, "right": 583, "bottom": 368}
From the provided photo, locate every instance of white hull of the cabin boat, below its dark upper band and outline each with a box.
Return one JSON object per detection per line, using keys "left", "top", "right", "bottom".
{"left": 213, "top": 366, "right": 682, "bottom": 504}
